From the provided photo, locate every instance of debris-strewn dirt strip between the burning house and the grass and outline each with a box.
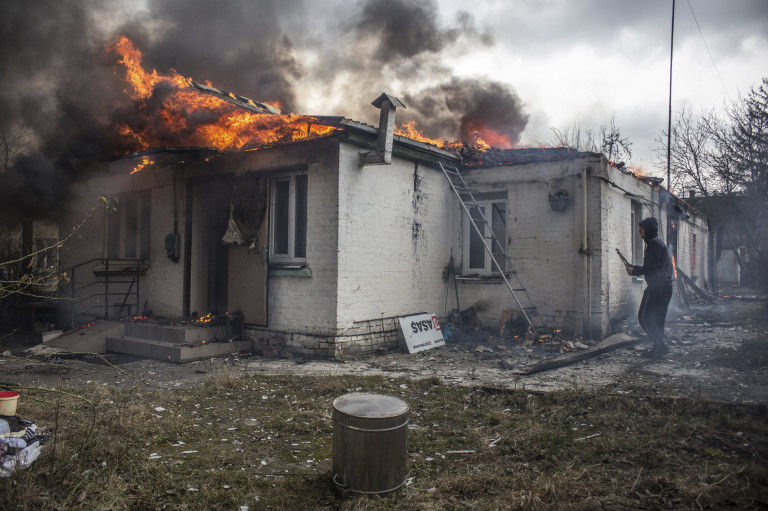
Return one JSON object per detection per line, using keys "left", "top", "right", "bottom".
{"left": 0, "top": 295, "right": 768, "bottom": 403}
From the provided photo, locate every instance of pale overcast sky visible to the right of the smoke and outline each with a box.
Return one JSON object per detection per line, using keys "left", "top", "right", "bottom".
{"left": 294, "top": 0, "right": 768, "bottom": 173}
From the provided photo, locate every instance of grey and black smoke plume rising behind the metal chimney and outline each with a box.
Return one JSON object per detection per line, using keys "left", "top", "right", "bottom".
{"left": 308, "top": 0, "right": 528, "bottom": 148}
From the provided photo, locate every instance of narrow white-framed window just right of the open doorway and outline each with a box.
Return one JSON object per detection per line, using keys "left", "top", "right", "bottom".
{"left": 270, "top": 173, "right": 307, "bottom": 264}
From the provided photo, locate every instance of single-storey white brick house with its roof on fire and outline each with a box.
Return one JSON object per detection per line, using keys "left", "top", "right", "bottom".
{"left": 51, "top": 41, "right": 709, "bottom": 357}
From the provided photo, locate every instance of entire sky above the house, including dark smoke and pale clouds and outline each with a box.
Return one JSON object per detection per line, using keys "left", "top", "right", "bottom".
{"left": 0, "top": 0, "right": 768, "bottom": 215}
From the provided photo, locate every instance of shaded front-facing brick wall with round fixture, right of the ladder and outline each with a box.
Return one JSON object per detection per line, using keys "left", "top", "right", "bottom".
{"left": 455, "top": 161, "right": 596, "bottom": 336}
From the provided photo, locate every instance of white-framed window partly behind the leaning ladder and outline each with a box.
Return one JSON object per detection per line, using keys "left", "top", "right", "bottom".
{"left": 464, "top": 200, "right": 507, "bottom": 273}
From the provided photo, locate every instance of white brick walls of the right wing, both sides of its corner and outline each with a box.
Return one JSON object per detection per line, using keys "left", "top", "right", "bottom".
{"left": 454, "top": 157, "right": 708, "bottom": 338}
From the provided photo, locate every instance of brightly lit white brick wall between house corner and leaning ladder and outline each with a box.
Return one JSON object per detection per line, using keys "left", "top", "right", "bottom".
{"left": 338, "top": 145, "right": 451, "bottom": 332}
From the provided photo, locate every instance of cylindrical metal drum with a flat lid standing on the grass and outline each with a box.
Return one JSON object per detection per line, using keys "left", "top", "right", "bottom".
{"left": 333, "top": 392, "right": 410, "bottom": 495}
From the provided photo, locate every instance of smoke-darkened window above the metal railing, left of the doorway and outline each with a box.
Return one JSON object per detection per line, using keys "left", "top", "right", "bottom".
{"left": 107, "top": 193, "right": 152, "bottom": 261}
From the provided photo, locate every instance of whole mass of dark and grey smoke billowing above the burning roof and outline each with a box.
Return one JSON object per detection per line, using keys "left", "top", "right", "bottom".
{"left": 0, "top": 0, "right": 527, "bottom": 224}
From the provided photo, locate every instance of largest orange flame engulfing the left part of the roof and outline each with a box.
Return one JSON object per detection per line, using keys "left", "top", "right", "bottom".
{"left": 108, "top": 37, "right": 338, "bottom": 155}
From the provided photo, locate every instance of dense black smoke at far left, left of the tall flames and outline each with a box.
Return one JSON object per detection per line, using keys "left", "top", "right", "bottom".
{"left": 0, "top": 0, "right": 129, "bottom": 224}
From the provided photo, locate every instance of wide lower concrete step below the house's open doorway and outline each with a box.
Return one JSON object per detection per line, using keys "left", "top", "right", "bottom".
{"left": 106, "top": 336, "right": 251, "bottom": 364}
